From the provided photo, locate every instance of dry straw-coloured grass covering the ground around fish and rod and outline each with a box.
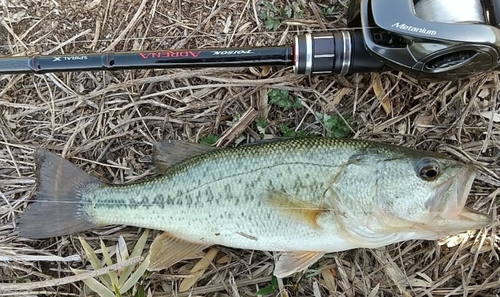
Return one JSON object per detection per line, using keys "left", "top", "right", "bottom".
{"left": 0, "top": 0, "right": 500, "bottom": 296}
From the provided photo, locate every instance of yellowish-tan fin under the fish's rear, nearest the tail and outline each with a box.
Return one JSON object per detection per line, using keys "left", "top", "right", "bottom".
{"left": 148, "top": 232, "right": 209, "bottom": 271}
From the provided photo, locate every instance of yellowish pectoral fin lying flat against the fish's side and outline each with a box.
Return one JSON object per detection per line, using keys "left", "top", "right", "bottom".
{"left": 266, "top": 190, "right": 329, "bottom": 228}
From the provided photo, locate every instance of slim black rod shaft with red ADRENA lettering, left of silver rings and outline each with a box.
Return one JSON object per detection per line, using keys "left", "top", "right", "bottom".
{"left": 0, "top": 46, "right": 293, "bottom": 74}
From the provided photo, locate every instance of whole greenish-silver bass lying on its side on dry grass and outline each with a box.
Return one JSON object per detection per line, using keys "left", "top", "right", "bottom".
{"left": 18, "top": 137, "right": 492, "bottom": 278}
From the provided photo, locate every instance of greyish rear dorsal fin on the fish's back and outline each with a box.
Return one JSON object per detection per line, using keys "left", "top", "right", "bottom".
{"left": 153, "top": 139, "right": 218, "bottom": 173}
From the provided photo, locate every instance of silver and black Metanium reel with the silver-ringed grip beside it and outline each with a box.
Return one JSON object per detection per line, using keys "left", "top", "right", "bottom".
{"left": 295, "top": 0, "right": 500, "bottom": 80}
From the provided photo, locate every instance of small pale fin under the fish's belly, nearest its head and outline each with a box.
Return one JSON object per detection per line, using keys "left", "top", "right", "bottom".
{"left": 274, "top": 252, "right": 325, "bottom": 278}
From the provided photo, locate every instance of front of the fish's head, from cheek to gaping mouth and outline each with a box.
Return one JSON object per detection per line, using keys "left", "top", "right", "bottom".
{"left": 377, "top": 151, "right": 492, "bottom": 239}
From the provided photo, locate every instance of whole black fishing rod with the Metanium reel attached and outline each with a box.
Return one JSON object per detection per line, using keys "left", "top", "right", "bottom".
{"left": 0, "top": 0, "right": 500, "bottom": 81}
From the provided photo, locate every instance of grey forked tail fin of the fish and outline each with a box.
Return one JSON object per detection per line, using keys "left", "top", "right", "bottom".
{"left": 18, "top": 149, "right": 102, "bottom": 239}
